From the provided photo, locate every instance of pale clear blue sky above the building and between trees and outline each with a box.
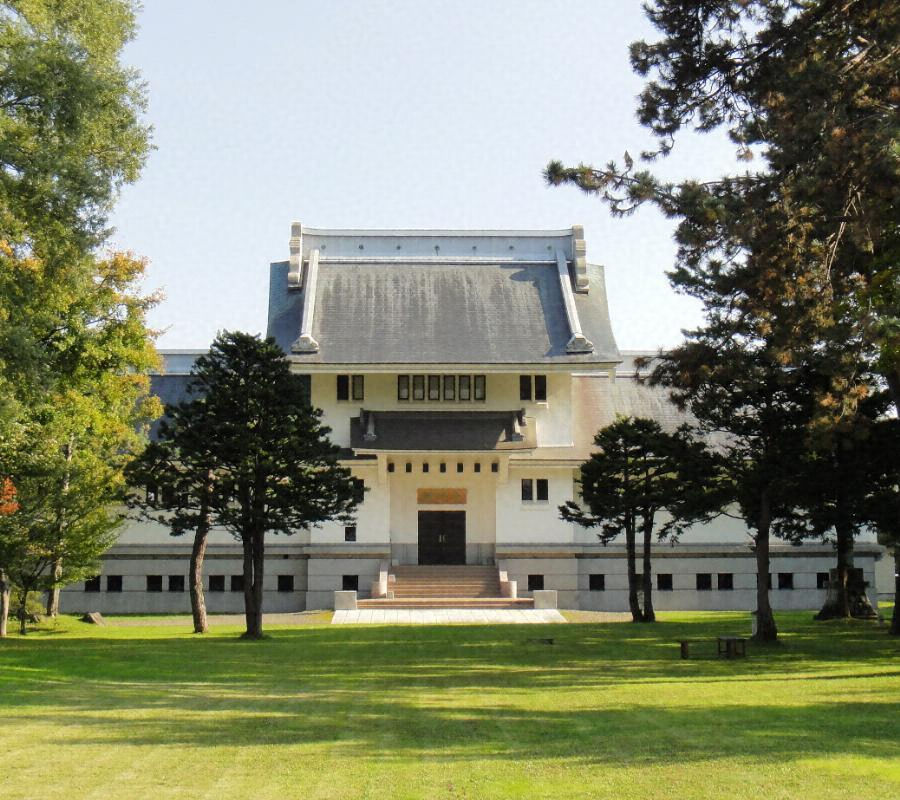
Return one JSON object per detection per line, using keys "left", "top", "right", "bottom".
{"left": 113, "top": 0, "right": 734, "bottom": 349}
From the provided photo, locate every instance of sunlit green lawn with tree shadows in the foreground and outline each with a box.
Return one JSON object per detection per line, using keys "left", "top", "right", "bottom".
{"left": 0, "top": 613, "right": 900, "bottom": 800}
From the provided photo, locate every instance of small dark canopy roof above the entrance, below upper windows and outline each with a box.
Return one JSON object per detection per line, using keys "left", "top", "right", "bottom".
{"left": 350, "top": 411, "right": 536, "bottom": 451}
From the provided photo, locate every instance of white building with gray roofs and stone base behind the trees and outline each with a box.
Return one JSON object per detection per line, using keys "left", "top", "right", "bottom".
{"left": 63, "top": 223, "right": 881, "bottom": 613}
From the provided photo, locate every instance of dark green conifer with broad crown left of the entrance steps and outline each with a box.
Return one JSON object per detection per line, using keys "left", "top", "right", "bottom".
{"left": 130, "top": 332, "right": 356, "bottom": 636}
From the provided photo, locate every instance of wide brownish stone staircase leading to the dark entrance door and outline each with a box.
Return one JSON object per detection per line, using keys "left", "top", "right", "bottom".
{"left": 358, "top": 565, "right": 534, "bottom": 609}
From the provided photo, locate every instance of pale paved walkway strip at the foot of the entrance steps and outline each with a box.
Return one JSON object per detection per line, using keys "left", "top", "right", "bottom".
{"left": 331, "top": 608, "right": 566, "bottom": 625}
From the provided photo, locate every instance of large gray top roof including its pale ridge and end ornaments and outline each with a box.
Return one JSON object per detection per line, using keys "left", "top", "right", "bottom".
{"left": 268, "top": 226, "right": 620, "bottom": 365}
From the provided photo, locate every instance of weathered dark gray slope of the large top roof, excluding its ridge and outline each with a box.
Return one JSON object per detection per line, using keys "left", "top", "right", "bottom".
{"left": 268, "top": 261, "right": 619, "bottom": 364}
